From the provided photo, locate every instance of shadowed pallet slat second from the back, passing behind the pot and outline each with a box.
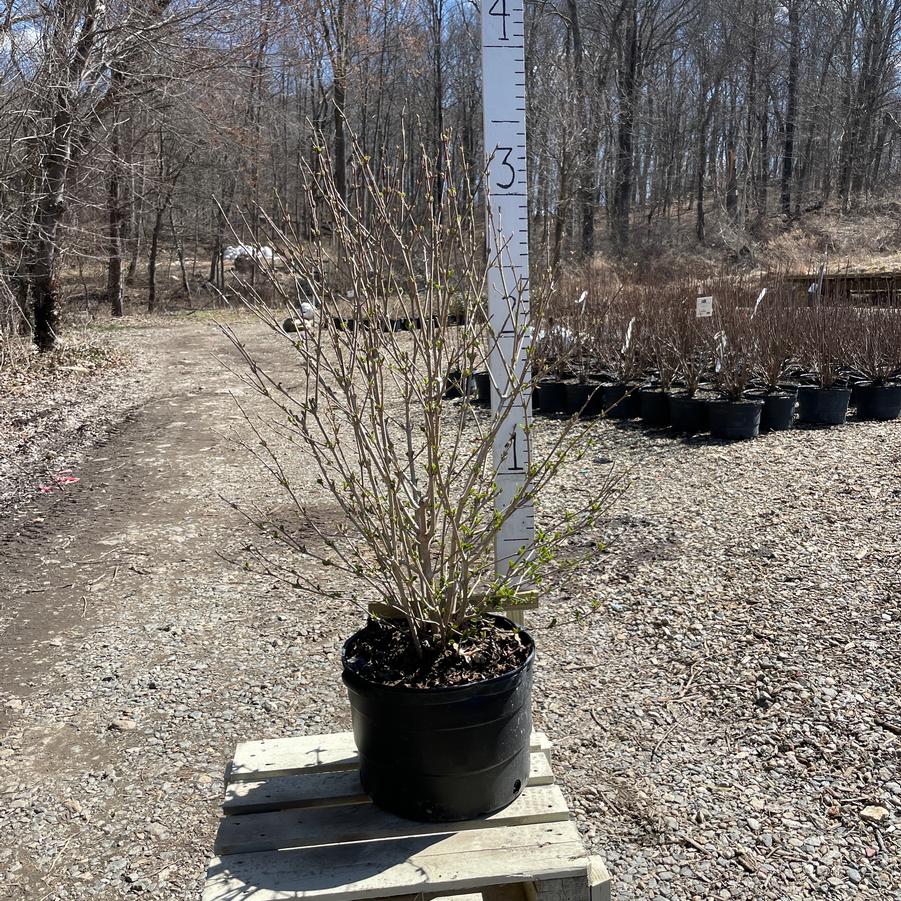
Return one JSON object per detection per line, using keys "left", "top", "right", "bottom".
{"left": 222, "top": 751, "right": 554, "bottom": 814}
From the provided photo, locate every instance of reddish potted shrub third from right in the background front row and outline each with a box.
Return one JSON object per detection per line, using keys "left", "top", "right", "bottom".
{"left": 752, "top": 290, "right": 799, "bottom": 432}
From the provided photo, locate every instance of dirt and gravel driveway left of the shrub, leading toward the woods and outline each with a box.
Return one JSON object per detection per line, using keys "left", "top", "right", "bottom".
{"left": 0, "top": 323, "right": 358, "bottom": 901}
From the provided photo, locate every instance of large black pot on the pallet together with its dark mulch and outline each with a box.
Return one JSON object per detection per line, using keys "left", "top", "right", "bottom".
{"left": 343, "top": 617, "right": 535, "bottom": 822}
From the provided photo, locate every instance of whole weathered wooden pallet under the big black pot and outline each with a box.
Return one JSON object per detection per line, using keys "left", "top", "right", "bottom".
{"left": 203, "top": 732, "right": 610, "bottom": 901}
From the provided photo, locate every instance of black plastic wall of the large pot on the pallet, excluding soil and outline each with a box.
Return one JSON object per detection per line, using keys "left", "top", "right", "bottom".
{"left": 342, "top": 617, "right": 535, "bottom": 822}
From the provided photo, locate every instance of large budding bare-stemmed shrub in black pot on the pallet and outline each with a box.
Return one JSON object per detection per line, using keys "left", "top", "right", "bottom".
{"left": 232, "top": 146, "right": 614, "bottom": 820}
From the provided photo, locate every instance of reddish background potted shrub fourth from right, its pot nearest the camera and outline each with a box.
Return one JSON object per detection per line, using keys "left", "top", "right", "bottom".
{"left": 709, "top": 292, "right": 763, "bottom": 440}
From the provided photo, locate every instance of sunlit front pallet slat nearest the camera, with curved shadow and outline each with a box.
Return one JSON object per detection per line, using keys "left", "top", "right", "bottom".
{"left": 203, "top": 822, "right": 588, "bottom": 901}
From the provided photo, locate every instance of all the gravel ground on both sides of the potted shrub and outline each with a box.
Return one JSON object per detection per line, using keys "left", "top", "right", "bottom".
{"left": 0, "top": 314, "right": 901, "bottom": 901}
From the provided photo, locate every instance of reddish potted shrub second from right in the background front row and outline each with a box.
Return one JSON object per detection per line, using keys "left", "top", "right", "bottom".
{"left": 798, "top": 296, "right": 851, "bottom": 425}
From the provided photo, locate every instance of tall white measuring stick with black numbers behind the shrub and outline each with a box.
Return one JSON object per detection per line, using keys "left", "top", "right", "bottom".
{"left": 482, "top": 0, "right": 535, "bottom": 588}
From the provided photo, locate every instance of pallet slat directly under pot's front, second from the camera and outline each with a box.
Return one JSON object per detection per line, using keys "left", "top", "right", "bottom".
{"left": 214, "top": 785, "right": 569, "bottom": 855}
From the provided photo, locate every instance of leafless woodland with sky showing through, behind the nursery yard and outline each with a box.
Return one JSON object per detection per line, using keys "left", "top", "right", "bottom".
{"left": 0, "top": 0, "right": 901, "bottom": 349}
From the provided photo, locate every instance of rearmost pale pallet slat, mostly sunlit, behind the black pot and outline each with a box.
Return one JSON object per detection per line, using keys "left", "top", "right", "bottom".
{"left": 228, "top": 732, "right": 550, "bottom": 782}
